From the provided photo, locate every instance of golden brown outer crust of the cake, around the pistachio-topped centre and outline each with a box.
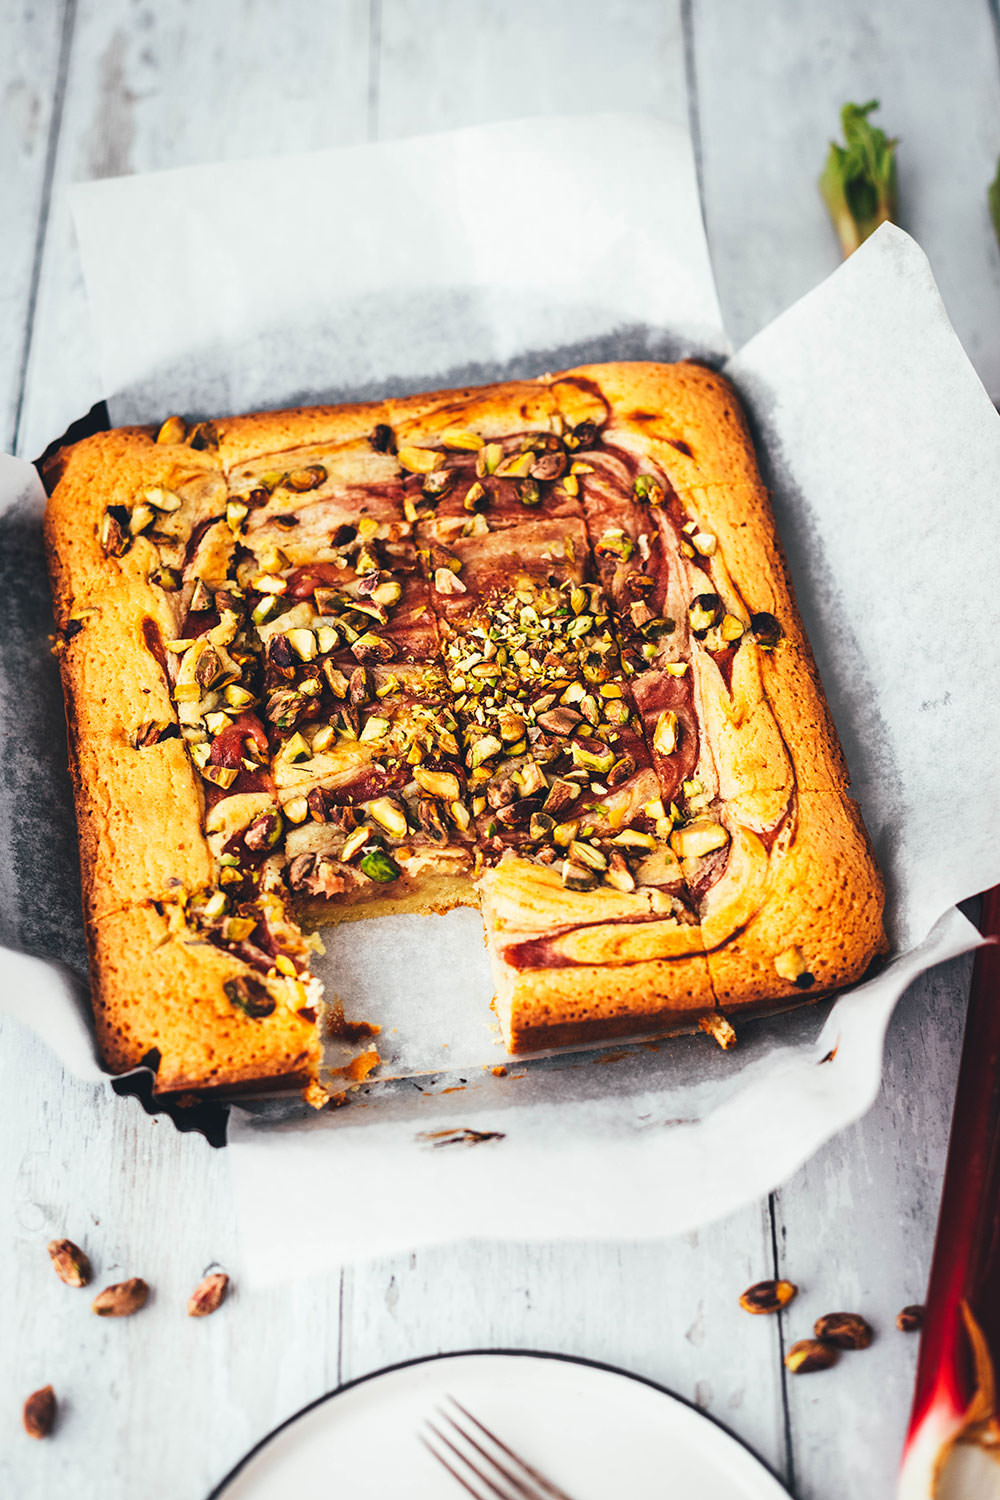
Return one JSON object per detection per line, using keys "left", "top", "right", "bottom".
{"left": 45, "top": 363, "right": 885, "bottom": 1089}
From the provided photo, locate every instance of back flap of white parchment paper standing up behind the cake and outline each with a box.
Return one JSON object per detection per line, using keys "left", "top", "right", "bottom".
{"left": 73, "top": 116, "right": 729, "bottom": 423}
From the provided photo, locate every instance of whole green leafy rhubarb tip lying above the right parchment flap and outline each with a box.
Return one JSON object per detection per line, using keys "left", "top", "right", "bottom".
{"left": 820, "top": 99, "right": 899, "bottom": 258}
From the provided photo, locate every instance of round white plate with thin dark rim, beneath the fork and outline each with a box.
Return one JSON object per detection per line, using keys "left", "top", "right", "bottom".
{"left": 208, "top": 1352, "right": 789, "bottom": 1500}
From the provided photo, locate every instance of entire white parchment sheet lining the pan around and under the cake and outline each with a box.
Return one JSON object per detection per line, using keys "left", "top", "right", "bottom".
{"left": 0, "top": 117, "right": 1000, "bottom": 1278}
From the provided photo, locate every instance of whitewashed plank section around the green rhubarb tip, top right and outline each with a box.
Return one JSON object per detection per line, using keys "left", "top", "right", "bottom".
{"left": 691, "top": 0, "right": 1000, "bottom": 396}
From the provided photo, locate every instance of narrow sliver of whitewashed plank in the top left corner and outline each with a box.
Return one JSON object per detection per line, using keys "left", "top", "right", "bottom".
{"left": 0, "top": 0, "right": 72, "bottom": 452}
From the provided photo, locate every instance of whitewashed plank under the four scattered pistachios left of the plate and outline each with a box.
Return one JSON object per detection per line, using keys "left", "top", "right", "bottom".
{"left": 0, "top": 0, "right": 369, "bottom": 1500}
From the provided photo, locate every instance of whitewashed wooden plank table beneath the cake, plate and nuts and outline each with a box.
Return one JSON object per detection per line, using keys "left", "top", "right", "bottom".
{"left": 0, "top": 0, "right": 1000, "bottom": 1500}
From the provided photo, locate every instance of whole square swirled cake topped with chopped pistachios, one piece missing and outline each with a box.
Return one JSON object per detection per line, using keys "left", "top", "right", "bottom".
{"left": 46, "top": 363, "right": 885, "bottom": 1098}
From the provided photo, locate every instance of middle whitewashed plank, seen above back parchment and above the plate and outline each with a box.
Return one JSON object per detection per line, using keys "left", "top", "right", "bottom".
{"left": 343, "top": 0, "right": 784, "bottom": 1488}
